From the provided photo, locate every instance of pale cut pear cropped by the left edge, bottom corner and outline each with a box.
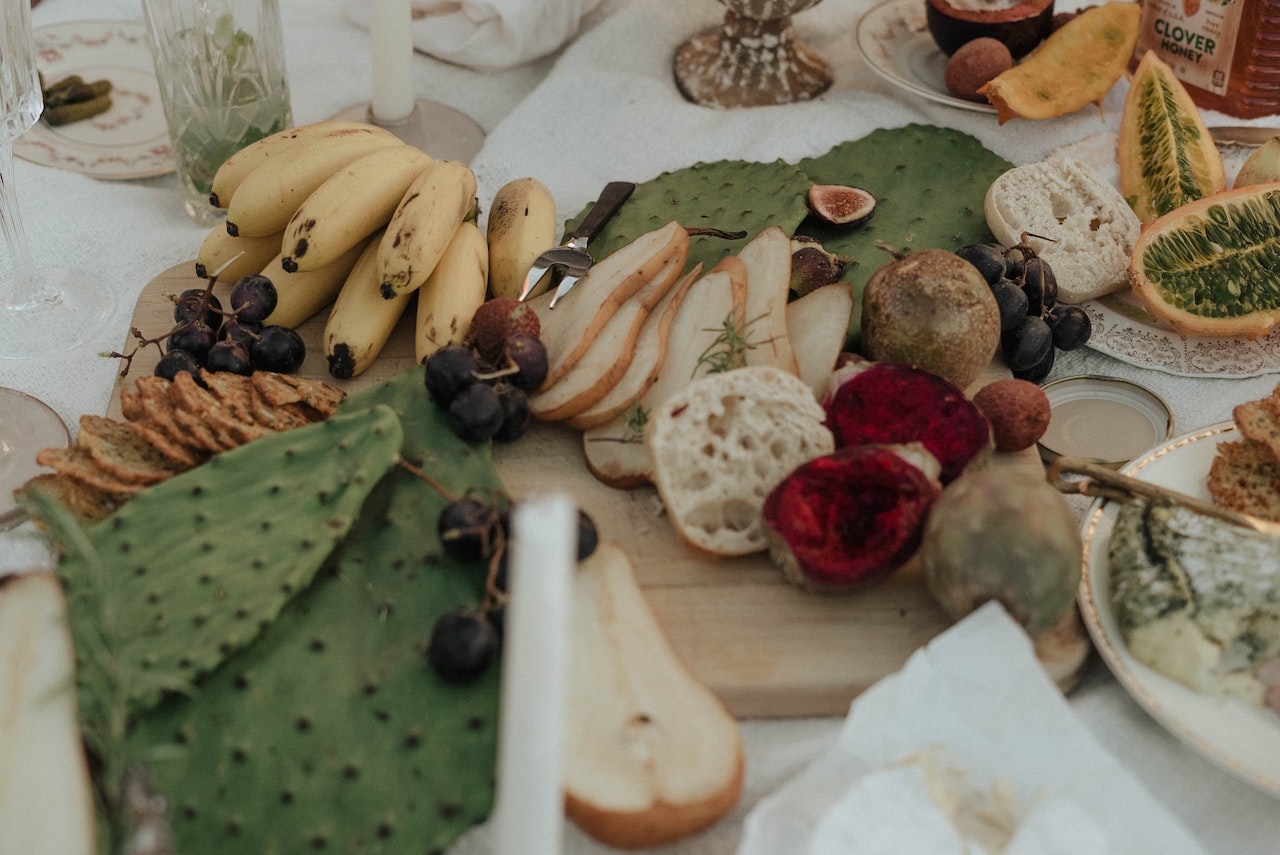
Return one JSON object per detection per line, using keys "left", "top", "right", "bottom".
{"left": 0, "top": 573, "right": 96, "bottom": 855}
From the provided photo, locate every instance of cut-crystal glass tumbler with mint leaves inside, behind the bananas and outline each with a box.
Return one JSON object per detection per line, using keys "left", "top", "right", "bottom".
{"left": 142, "top": 0, "right": 292, "bottom": 225}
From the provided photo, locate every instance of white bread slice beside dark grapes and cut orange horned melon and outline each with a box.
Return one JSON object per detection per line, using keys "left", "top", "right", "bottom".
{"left": 986, "top": 157, "right": 1140, "bottom": 303}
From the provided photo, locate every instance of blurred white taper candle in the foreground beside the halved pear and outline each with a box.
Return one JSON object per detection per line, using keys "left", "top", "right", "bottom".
{"left": 494, "top": 494, "right": 577, "bottom": 855}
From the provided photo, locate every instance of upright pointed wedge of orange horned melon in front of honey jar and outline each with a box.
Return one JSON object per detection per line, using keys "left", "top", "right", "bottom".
{"left": 1117, "top": 51, "right": 1226, "bottom": 223}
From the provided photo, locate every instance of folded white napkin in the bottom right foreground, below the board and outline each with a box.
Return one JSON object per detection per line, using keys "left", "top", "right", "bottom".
{"left": 737, "top": 602, "right": 1203, "bottom": 855}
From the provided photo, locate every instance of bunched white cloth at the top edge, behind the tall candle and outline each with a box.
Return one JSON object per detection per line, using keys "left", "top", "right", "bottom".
{"left": 346, "top": 0, "right": 600, "bottom": 72}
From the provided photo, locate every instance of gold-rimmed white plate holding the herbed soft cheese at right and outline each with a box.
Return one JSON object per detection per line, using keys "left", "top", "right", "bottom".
{"left": 1079, "top": 422, "right": 1280, "bottom": 796}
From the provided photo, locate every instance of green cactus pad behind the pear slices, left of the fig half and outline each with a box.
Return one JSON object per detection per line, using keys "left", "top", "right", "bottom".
{"left": 564, "top": 160, "right": 810, "bottom": 277}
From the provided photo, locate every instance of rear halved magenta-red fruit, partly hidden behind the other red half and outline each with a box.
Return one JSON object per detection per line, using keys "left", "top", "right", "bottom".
{"left": 823, "top": 362, "right": 992, "bottom": 484}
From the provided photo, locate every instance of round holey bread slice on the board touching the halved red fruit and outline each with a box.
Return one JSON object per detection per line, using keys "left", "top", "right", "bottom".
{"left": 645, "top": 365, "right": 835, "bottom": 555}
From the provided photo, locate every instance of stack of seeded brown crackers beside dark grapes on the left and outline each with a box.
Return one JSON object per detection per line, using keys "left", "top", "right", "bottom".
{"left": 23, "top": 370, "right": 346, "bottom": 521}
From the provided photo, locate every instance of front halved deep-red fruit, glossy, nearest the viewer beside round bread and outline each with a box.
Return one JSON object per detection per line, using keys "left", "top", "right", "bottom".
{"left": 763, "top": 443, "right": 942, "bottom": 593}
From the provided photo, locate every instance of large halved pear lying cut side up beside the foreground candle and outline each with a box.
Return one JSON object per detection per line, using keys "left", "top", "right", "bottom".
{"left": 564, "top": 541, "right": 744, "bottom": 850}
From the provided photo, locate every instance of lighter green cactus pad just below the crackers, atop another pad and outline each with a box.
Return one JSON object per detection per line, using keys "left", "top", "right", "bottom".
{"left": 23, "top": 407, "right": 403, "bottom": 744}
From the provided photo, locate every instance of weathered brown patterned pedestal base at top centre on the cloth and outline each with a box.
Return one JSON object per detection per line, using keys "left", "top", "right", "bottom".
{"left": 673, "top": 0, "right": 832, "bottom": 108}
